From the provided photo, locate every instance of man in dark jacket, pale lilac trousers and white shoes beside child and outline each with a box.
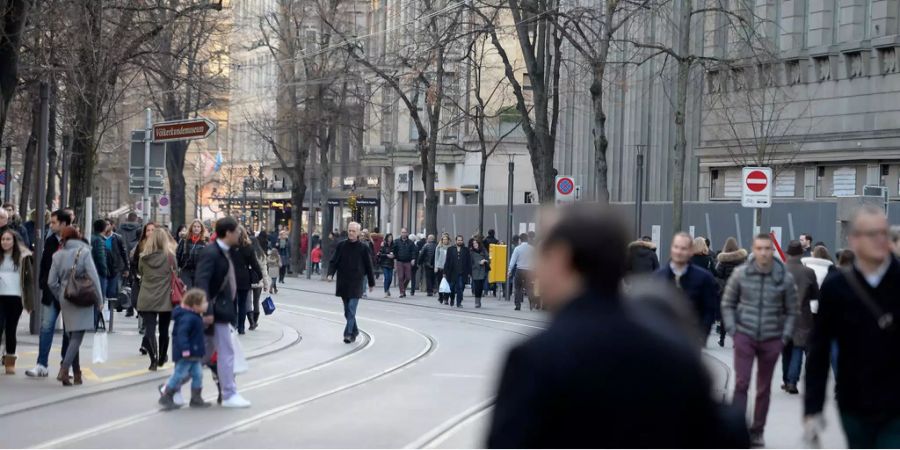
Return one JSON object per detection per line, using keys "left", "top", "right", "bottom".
{"left": 194, "top": 217, "right": 250, "bottom": 408}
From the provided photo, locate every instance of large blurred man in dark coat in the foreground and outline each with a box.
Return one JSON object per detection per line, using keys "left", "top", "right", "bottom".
{"left": 487, "top": 205, "right": 748, "bottom": 448}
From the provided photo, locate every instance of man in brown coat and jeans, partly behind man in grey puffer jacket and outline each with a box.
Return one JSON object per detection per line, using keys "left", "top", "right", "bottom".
{"left": 781, "top": 241, "right": 819, "bottom": 394}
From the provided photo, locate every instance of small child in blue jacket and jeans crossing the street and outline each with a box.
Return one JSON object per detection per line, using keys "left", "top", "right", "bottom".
{"left": 159, "top": 289, "right": 210, "bottom": 410}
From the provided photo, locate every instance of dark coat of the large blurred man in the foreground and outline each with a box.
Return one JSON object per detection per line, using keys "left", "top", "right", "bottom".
{"left": 487, "top": 293, "right": 749, "bottom": 448}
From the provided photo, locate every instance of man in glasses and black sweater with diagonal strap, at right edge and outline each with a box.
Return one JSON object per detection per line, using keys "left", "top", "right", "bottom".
{"left": 805, "top": 205, "right": 900, "bottom": 448}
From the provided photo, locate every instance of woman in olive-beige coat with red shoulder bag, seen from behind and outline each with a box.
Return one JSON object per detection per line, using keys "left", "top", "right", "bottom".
{"left": 137, "top": 228, "right": 175, "bottom": 370}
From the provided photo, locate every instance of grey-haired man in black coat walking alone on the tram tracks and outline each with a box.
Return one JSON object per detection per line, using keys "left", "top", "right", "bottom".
{"left": 328, "top": 222, "right": 374, "bottom": 344}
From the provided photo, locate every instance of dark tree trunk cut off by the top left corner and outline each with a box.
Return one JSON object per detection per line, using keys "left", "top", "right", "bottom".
{"left": 0, "top": 0, "right": 31, "bottom": 146}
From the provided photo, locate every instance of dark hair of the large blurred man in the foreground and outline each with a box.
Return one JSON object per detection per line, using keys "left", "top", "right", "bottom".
{"left": 541, "top": 204, "right": 628, "bottom": 294}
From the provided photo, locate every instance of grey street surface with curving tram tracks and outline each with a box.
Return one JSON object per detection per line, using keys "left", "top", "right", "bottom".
{"left": 0, "top": 278, "right": 845, "bottom": 448}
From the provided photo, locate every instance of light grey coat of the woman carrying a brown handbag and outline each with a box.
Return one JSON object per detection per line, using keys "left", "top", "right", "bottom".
{"left": 47, "top": 239, "right": 103, "bottom": 331}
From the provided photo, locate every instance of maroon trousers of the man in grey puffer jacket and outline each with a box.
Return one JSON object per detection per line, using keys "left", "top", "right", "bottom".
{"left": 732, "top": 333, "right": 783, "bottom": 433}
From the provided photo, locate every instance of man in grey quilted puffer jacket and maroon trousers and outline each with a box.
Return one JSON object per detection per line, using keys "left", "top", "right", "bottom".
{"left": 722, "top": 234, "right": 797, "bottom": 448}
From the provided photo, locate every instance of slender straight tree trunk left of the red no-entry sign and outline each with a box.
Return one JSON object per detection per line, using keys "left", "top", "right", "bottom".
{"left": 672, "top": 0, "right": 693, "bottom": 233}
